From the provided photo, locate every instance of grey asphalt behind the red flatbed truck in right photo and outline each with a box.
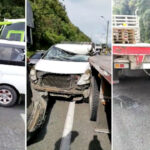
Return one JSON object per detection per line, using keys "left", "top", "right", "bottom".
{"left": 113, "top": 72, "right": 150, "bottom": 150}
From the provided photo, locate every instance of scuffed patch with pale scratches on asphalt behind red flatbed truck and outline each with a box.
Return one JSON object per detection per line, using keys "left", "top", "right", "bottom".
{"left": 114, "top": 95, "right": 139, "bottom": 109}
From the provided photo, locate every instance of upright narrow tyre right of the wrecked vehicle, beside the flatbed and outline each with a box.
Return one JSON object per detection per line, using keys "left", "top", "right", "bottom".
{"left": 89, "top": 76, "right": 99, "bottom": 121}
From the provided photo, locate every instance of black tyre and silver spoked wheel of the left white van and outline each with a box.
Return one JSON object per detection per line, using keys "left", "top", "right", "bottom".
{"left": 0, "top": 85, "right": 18, "bottom": 107}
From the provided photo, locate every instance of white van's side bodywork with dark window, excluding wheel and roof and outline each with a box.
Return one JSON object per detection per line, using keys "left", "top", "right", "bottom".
{"left": 0, "top": 45, "right": 26, "bottom": 94}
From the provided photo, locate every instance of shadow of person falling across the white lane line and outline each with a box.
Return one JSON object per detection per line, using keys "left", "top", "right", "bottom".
{"left": 54, "top": 131, "right": 79, "bottom": 150}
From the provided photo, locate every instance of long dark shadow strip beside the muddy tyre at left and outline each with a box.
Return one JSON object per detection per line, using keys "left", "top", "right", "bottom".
{"left": 28, "top": 97, "right": 56, "bottom": 146}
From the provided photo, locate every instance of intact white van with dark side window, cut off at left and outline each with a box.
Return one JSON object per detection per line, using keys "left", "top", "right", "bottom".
{"left": 0, "top": 40, "right": 26, "bottom": 107}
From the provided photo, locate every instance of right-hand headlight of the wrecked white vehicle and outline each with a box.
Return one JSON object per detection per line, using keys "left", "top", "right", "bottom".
{"left": 77, "top": 70, "right": 91, "bottom": 85}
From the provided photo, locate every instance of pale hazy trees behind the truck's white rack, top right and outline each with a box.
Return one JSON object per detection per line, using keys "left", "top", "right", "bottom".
{"left": 113, "top": 0, "right": 150, "bottom": 43}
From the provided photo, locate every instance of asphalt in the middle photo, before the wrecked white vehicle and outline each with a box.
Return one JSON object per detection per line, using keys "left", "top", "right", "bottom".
{"left": 28, "top": 100, "right": 110, "bottom": 150}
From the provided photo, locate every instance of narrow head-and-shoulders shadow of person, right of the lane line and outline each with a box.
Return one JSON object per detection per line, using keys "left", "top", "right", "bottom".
{"left": 88, "top": 135, "right": 103, "bottom": 150}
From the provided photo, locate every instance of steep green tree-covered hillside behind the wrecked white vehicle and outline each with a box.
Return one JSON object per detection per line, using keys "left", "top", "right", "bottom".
{"left": 30, "top": 0, "right": 90, "bottom": 50}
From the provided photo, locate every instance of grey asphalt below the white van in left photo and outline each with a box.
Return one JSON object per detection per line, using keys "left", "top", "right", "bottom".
{"left": 0, "top": 104, "right": 25, "bottom": 150}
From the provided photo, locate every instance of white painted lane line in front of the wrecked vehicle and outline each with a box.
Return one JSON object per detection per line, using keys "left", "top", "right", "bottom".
{"left": 60, "top": 102, "right": 75, "bottom": 150}
